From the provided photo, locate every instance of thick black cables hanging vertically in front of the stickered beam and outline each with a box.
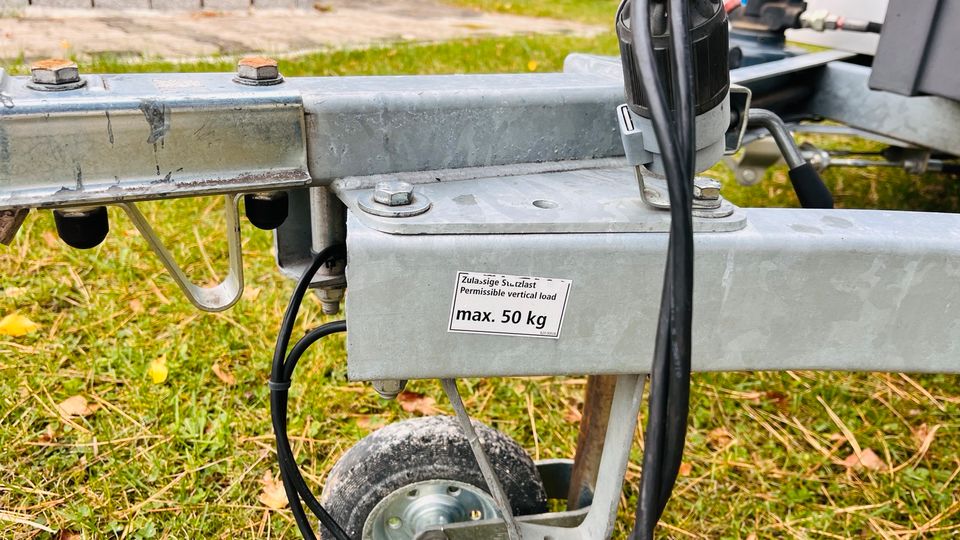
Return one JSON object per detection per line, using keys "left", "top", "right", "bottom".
{"left": 630, "top": 0, "right": 696, "bottom": 539}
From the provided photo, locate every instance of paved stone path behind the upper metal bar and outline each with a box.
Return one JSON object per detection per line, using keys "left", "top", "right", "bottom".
{"left": 0, "top": 0, "right": 604, "bottom": 61}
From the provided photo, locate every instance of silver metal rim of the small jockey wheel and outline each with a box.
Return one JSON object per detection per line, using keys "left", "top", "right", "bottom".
{"left": 363, "top": 480, "right": 498, "bottom": 540}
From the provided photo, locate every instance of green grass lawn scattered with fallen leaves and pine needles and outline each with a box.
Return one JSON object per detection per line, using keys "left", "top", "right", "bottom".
{"left": 0, "top": 4, "right": 960, "bottom": 540}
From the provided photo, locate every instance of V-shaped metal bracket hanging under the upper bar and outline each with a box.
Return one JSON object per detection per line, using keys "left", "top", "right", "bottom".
{"left": 120, "top": 194, "right": 243, "bottom": 311}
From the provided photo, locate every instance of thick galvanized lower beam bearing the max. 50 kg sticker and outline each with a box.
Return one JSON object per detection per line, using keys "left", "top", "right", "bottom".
{"left": 346, "top": 209, "right": 960, "bottom": 380}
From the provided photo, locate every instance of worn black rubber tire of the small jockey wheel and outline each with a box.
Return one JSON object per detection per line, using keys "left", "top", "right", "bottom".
{"left": 320, "top": 416, "right": 547, "bottom": 539}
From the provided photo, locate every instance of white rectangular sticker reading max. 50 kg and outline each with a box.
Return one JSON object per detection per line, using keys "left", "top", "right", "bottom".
{"left": 448, "top": 272, "right": 573, "bottom": 339}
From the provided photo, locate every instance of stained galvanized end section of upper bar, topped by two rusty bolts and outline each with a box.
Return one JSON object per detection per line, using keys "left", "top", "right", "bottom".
{"left": 0, "top": 74, "right": 309, "bottom": 208}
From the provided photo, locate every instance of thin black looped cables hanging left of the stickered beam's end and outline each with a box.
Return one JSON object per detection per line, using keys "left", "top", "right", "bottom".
{"left": 270, "top": 245, "right": 350, "bottom": 540}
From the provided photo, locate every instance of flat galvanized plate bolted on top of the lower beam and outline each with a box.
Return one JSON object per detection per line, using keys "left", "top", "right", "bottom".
{"left": 333, "top": 166, "right": 746, "bottom": 235}
